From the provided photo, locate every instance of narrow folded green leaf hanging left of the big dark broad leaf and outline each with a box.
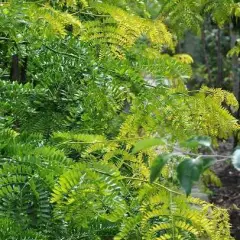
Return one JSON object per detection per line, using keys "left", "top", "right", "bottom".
{"left": 150, "top": 154, "right": 171, "bottom": 183}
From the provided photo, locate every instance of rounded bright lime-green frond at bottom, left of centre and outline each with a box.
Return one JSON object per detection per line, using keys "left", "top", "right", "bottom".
{"left": 51, "top": 163, "right": 127, "bottom": 238}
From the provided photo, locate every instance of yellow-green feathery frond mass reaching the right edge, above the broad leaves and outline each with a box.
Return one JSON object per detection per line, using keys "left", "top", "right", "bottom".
{"left": 115, "top": 87, "right": 239, "bottom": 142}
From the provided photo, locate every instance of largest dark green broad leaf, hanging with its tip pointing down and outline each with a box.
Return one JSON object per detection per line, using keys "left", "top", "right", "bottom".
{"left": 177, "top": 157, "right": 215, "bottom": 196}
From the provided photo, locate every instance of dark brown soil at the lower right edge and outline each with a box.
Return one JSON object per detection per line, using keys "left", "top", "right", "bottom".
{"left": 210, "top": 143, "right": 240, "bottom": 240}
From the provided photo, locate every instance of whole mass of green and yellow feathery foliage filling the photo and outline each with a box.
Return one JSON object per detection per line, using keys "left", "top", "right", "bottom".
{"left": 0, "top": 0, "right": 240, "bottom": 240}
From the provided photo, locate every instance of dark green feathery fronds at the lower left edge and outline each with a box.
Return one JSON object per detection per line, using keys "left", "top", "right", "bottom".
{"left": 0, "top": 130, "right": 68, "bottom": 227}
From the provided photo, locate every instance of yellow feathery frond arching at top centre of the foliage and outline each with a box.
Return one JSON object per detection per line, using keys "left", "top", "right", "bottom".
{"left": 81, "top": 4, "right": 174, "bottom": 57}
